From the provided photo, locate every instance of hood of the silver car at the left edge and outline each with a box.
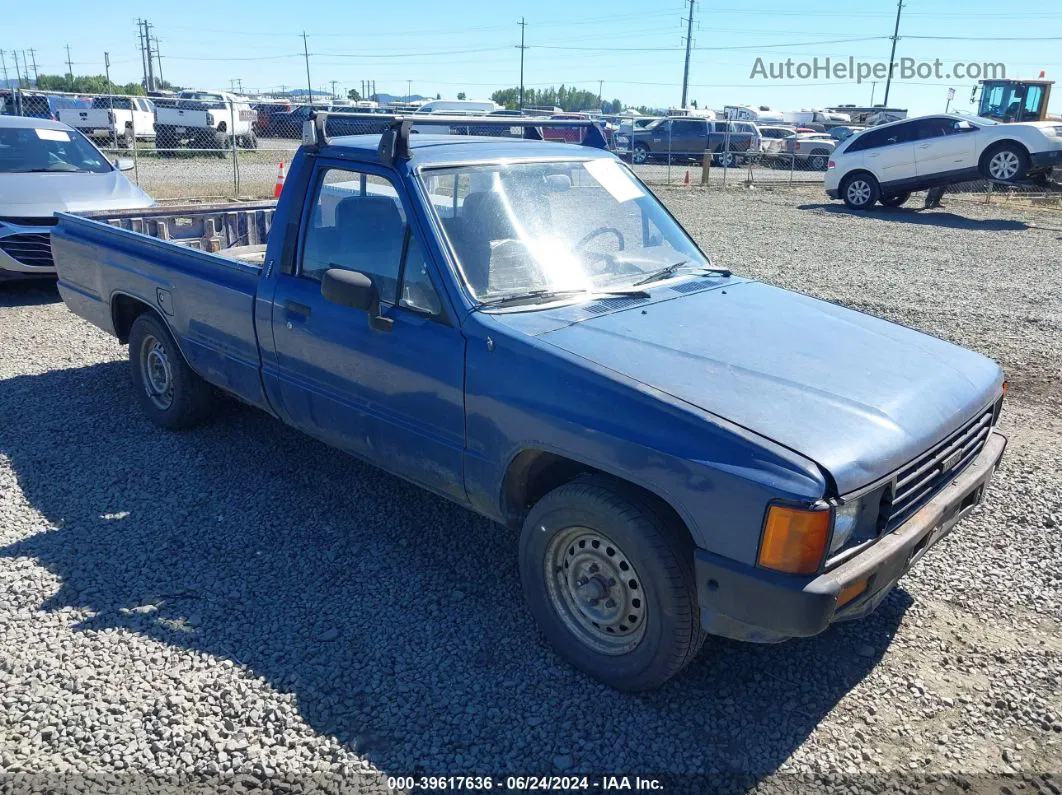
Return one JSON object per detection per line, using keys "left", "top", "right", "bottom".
{"left": 0, "top": 170, "right": 155, "bottom": 218}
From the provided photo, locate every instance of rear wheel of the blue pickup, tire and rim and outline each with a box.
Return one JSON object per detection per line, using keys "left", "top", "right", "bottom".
{"left": 130, "top": 312, "right": 213, "bottom": 431}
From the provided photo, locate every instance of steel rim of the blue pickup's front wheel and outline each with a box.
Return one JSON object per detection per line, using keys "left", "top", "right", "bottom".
{"left": 545, "top": 526, "right": 646, "bottom": 656}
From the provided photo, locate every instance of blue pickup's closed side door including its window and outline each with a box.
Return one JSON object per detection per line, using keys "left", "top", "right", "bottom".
{"left": 266, "top": 161, "right": 464, "bottom": 501}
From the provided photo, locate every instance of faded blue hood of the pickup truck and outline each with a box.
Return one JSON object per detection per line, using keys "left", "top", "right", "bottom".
{"left": 539, "top": 281, "right": 1003, "bottom": 494}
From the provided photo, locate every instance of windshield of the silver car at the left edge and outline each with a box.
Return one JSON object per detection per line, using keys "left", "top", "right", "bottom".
{"left": 0, "top": 127, "right": 112, "bottom": 174}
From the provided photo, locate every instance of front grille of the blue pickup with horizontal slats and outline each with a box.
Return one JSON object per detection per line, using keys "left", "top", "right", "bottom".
{"left": 877, "top": 409, "right": 993, "bottom": 533}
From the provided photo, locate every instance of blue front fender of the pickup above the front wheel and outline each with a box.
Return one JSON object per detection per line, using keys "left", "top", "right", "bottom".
{"left": 465, "top": 313, "right": 827, "bottom": 564}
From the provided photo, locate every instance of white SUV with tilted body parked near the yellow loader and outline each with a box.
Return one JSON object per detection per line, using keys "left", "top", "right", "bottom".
{"left": 825, "top": 115, "right": 1062, "bottom": 210}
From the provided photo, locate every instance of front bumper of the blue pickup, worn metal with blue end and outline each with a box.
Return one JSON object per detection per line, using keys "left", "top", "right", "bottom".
{"left": 695, "top": 431, "right": 1007, "bottom": 643}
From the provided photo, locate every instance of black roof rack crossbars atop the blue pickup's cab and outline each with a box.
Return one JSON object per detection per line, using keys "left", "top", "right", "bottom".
{"left": 303, "top": 111, "right": 609, "bottom": 166}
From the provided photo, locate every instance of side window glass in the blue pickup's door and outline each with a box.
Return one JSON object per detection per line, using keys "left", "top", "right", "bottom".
{"left": 298, "top": 169, "right": 442, "bottom": 314}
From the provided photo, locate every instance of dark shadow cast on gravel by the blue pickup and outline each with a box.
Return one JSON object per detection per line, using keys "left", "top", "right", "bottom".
{"left": 0, "top": 362, "right": 910, "bottom": 782}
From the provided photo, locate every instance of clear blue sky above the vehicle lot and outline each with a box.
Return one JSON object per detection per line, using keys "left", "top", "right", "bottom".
{"left": 8, "top": 0, "right": 1062, "bottom": 113}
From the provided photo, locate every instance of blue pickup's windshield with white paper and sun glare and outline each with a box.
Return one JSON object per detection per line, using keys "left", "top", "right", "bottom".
{"left": 421, "top": 158, "right": 710, "bottom": 303}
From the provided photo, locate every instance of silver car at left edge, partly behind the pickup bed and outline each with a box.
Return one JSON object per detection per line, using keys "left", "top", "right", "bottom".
{"left": 0, "top": 116, "right": 155, "bottom": 281}
